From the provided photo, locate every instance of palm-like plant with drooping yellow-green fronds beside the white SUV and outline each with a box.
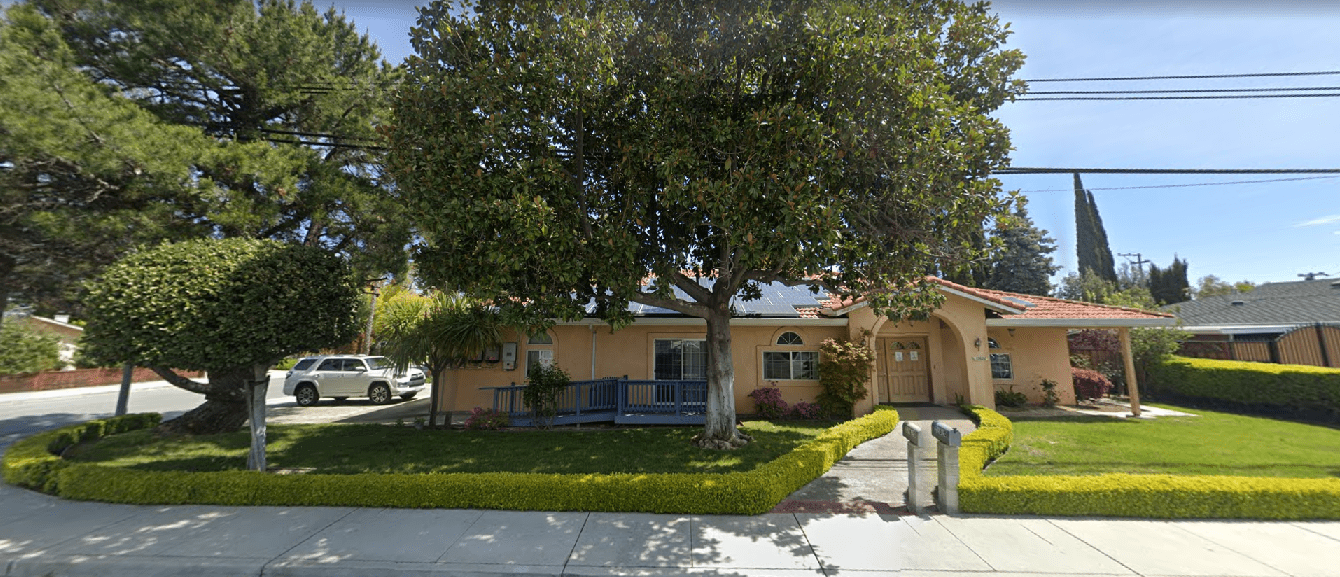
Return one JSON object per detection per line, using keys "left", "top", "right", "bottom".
{"left": 375, "top": 292, "right": 503, "bottom": 427}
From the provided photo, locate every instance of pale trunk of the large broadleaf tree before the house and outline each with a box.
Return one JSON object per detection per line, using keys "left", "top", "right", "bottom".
{"left": 693, "top": 309, "right": 753, "bottom": 450}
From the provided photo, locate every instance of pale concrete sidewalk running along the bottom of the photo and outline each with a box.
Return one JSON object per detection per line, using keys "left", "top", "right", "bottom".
{"left": 0, "top": 486, "right": 1340, "bottom": 577}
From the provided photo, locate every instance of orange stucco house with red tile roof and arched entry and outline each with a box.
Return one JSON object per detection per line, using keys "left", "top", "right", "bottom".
{"left": 440, "top": 280, "right": 1173, "bottom": 414}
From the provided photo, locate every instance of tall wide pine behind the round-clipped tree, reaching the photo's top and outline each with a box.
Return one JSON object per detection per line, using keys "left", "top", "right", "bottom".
{"left": 11, "top": 0, "right": 409, "bottom": 311}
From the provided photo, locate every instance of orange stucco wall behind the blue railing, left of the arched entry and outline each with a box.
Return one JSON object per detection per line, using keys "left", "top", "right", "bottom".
{"left": 441, "top": 321, "right": 846, "bottom": 412}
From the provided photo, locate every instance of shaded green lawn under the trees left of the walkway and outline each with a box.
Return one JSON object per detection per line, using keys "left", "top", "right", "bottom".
{"left": 66, "top": 422, "right": 833, "bottom": 474}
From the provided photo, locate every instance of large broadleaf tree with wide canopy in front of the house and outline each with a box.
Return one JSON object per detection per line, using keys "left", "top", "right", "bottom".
{"left": 389, "top": 0, "right": 1022, "bottom": 447}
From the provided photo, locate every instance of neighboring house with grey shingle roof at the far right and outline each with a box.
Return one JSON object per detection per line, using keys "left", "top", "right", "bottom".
{"left": 1164, "top": 278, "right": 1340, "bottom": 367}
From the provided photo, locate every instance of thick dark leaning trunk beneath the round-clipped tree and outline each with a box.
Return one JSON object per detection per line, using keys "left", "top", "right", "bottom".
{"left": 151, "top": 367, "right": 252, "bottom": 435}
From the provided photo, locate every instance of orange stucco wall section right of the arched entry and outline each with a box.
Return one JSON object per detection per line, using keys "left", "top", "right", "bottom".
{"left": 988, "top": 327, "right": 1075, "bottom": 404}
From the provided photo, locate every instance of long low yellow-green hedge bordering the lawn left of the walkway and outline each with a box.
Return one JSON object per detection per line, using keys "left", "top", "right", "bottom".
{"left": 4, "top": 410, "right": 898, "bottom": 514}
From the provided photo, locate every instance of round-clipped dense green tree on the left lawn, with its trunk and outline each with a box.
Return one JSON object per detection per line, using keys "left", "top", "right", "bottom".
{"left": 80, "top": 238, "right": 359, "bottom": 434}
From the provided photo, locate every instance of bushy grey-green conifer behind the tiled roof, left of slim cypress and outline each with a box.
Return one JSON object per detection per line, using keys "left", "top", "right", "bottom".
{"left": 985, "top": 198, "right": 1060, "bottom": 295}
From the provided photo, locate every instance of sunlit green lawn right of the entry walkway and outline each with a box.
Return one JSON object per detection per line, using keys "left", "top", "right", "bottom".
{"left": 985, "top": 406, "right": 1340, "bottom": 478}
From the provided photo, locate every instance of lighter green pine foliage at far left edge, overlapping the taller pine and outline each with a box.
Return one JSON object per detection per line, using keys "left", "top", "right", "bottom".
{"left": 0, "top": 4, "right": 280, "bottom": 321}
